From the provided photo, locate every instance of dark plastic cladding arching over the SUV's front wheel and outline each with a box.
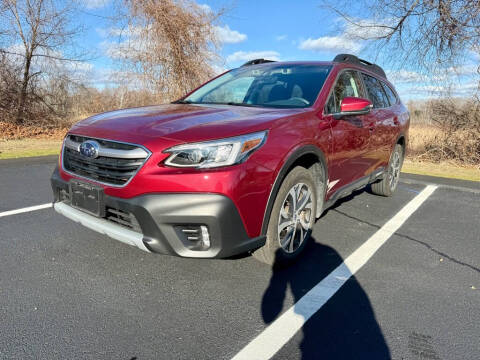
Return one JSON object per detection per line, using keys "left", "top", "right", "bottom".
{"left": 261, "top": 145, "right": 328, "bottom": 235}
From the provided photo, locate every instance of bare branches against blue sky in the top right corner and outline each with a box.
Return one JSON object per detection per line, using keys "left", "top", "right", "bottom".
{"left": 324, "top": 0, "right": 480, "bottom": 72}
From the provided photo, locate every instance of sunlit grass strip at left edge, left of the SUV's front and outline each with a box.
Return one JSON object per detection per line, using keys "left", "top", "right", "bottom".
{"left": 0, "top": 139, "right": 62, "bottom": 159}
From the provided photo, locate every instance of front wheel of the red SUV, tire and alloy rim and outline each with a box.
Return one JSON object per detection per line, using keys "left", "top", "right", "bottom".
{"left": 253, "top": 166, "right": 317, "bottom": 267}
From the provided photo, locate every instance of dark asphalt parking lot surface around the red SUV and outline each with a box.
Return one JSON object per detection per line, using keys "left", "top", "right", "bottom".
{"left": 0, "top": 158, "right": 480, "bottom": 360}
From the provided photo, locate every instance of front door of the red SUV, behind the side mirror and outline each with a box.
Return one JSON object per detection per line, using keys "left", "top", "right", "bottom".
{"left": 324, "top": 70, "right": 371, "bottom": 194}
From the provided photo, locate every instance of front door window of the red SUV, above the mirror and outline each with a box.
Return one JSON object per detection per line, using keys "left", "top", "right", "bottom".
{"left": 325, "top": 71, "right": 362, "bottom": 114}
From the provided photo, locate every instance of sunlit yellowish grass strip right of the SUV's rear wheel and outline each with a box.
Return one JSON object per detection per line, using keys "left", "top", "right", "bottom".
{"left": 402, "top": 159, "right": 480, "bottom": 181}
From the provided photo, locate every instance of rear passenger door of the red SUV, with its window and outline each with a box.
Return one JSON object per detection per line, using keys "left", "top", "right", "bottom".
{"left": 362, "top": 73, "right": 393, "bottom": 174}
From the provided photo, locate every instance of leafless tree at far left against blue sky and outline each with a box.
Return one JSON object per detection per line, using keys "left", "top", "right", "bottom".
{"left": 0, "top": 0, "right": 84, "bottom": 123}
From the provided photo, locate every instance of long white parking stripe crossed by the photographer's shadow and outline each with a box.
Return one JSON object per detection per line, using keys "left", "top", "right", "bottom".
{"left": 233, "top": 185, "right": 437, "bottom": 360}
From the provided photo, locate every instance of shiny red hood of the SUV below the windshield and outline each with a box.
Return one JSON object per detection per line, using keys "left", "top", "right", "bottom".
{"left": 71, "top": 104, "right": 305, "bottom": 150}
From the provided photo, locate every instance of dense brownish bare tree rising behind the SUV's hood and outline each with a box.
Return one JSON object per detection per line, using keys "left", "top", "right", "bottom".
{"left": 110, "top": 0, "right": 219, "bottom": 101}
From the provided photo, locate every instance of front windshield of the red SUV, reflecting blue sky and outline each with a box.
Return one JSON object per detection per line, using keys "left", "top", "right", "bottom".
{"left": 181, "top": 63, "right": 331, "bottom": 108}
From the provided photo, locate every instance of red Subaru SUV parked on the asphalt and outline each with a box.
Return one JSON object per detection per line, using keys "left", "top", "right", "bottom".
{"left": 52, "top": 54, "right": 409, "bottom": 264}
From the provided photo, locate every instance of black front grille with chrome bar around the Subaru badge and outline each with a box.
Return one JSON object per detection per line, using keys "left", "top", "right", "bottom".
{"left": 63, "top": 135, "right": 149, "bottom": 186}
